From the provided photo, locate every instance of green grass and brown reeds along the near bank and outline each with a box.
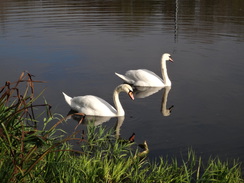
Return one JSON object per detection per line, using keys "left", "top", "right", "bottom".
{"left": 0, "top": 73, "right": 244, "bottom": 183}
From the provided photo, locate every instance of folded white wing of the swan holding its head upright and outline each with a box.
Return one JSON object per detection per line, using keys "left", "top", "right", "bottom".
{"left": 125, "top": 69, "right": 164, "bottom": 87}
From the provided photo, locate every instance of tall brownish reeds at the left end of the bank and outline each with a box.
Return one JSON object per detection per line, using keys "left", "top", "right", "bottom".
{"left": 0, "top": 72, "right": 82, "bottom": 182}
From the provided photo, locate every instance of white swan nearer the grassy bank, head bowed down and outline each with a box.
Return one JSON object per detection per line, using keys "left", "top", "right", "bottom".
{"left": 63, "top": 84, "right": 134, "bottom": 116}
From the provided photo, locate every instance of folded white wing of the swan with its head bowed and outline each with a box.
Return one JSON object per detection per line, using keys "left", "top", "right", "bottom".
{"left": 71, "top": 95, "right": 117, "bottom": 116}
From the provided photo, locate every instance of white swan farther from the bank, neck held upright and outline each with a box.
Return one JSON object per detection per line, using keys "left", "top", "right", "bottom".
{"left": 115, "top": 53, "right": 173, "bottom": 87}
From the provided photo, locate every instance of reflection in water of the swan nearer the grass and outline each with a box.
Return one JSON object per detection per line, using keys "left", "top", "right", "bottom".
{"left": 66, "top": 110, "right": 125, "bottom": 139}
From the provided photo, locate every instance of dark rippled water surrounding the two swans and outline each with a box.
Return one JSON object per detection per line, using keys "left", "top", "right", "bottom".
{"left": 0, "top": 0, "right": 244, "bottom": 165}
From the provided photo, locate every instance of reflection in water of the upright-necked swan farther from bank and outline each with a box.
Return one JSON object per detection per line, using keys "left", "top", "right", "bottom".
{"left": 133, "top": 86, "right": 174, "bottom": 116}
